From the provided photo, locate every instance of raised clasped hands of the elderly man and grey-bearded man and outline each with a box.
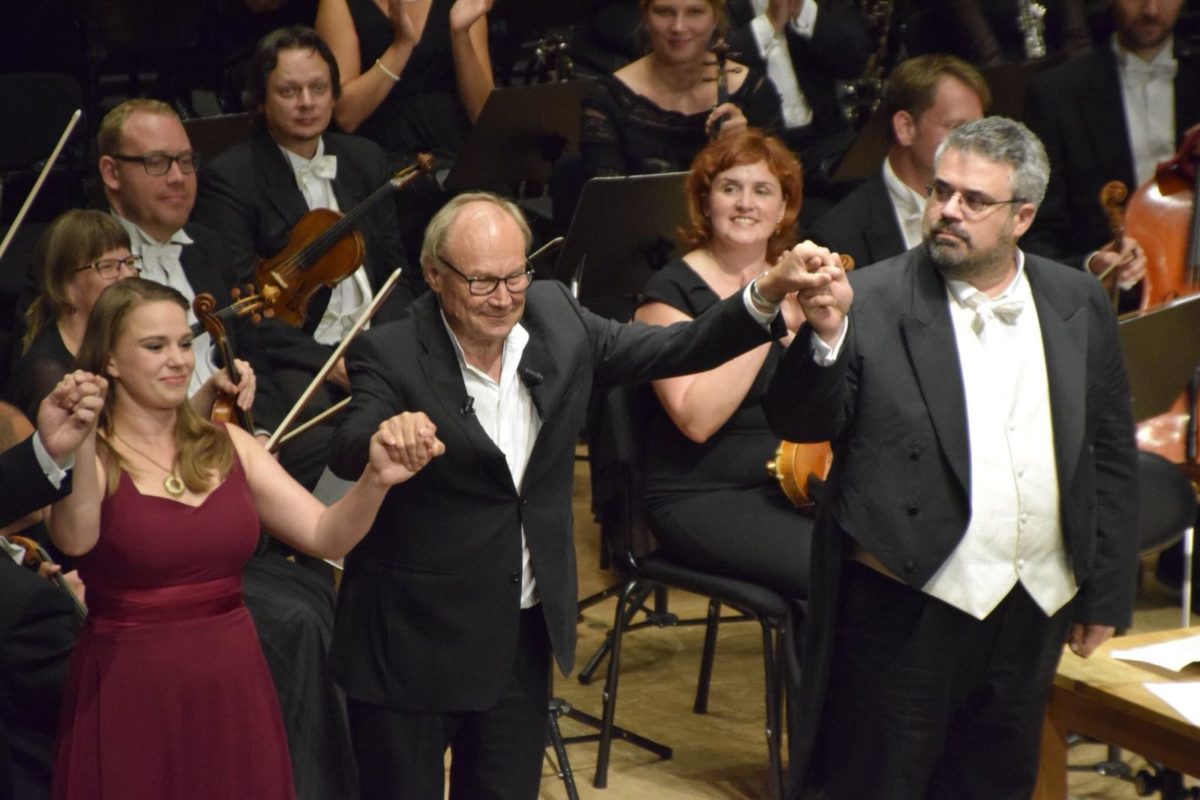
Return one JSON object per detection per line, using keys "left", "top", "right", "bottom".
{"left": 755, "top": 241, "right": 854, "bottom": 344}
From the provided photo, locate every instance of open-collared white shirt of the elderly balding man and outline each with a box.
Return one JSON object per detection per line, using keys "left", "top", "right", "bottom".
{"left": 442, "top": 314, "right": 541, "bottom": 608}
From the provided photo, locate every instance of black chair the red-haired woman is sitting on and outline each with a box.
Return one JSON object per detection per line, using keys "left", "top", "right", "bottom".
{"left": 589, "top": 385, "right": 792, "bottom": 798}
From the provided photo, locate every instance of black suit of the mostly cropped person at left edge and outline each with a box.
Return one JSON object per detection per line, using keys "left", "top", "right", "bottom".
{"left": 0, "top": 438, "right": 77, "bottom": 800}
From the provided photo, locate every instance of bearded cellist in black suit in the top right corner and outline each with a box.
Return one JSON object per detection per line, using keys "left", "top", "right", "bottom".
{"left": 1025, "top": 0, "right": 1200, "bottom": 306}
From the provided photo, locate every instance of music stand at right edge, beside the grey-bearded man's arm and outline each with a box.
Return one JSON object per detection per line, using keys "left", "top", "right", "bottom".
{"left": 1117, "top": 295, "right": 1200, "bottom": 420}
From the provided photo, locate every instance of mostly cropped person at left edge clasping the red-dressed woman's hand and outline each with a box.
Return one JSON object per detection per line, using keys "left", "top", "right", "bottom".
{"left": 0, "top": 372, "right": 107, "bottom": 800}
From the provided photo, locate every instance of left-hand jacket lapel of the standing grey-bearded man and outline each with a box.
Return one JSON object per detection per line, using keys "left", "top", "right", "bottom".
{"left": 900, "top": 255, "right": 971, "bottom": 492}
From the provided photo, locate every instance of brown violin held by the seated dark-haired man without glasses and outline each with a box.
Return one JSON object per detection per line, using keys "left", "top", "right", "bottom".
{"left": 254, "top": 154, "right": 433, "bottom": 327}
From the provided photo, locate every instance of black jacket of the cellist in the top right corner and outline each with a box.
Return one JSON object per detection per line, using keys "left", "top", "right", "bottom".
{"left": 1022, "top": 40, "right": 1200, "bottom": 263}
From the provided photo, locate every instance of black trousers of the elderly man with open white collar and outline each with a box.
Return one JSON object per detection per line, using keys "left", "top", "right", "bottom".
{"left": 348, "top": 606, "right": 551, "bottom": 800}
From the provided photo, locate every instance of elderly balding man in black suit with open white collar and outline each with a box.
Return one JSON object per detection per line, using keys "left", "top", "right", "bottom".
{"left": 331, "top": 193, "right": 832, "bottom": 800}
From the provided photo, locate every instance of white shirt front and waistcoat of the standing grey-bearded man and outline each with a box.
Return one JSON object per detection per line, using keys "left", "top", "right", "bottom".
{"left": 924, "top": 256, "right": 1078, "bottom": 619}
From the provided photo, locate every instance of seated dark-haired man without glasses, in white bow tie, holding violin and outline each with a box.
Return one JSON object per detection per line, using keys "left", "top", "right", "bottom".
{"left": 194, "top": 25, "right": 421, "bottom": 488}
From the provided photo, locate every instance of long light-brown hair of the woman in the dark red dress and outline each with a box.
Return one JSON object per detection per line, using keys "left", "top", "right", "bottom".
{"left": 76, "top": 278, "right": 234, "bottom": 494}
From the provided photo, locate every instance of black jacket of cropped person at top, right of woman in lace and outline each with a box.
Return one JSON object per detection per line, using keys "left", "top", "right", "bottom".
{"left": 727, "top": 0, "right": 871, "bottom": 140}
